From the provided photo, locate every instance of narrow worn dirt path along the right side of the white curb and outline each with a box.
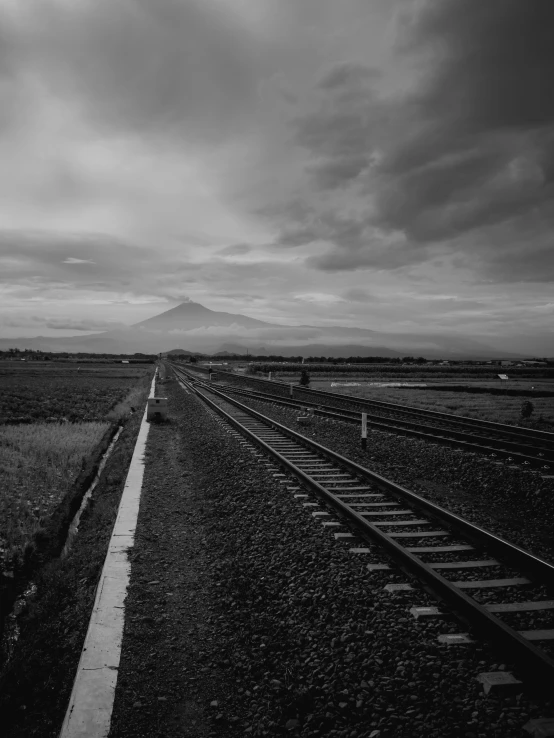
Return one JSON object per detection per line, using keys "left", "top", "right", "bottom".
{"left": 110, "top": 391, "right": 228, "bottom": 738}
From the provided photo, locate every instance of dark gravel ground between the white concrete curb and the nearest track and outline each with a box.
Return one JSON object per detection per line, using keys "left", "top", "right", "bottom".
{"left": 104, "top": 382, "right": 554, "bottom": 738}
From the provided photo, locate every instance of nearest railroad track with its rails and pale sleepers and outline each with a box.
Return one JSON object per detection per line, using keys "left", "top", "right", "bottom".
{"left": 174, "top": 367, "right": 554, "bottom": 687}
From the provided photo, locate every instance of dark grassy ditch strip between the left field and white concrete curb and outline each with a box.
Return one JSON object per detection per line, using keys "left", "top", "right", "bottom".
{"left": 0, "top": 387, "right": 148, "bottom": 738}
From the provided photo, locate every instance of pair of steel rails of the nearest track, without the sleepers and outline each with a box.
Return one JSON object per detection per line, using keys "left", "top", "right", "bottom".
{"left": 175, "top": 368, "right": 554, "bottom": 685}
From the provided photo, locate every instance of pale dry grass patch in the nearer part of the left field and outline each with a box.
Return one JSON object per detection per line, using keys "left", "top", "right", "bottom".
{"left": 0, "top": 422, "right": 110, "bottom": 569}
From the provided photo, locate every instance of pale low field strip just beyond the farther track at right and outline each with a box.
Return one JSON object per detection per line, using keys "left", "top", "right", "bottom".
{"left": 310, "top": 380, "right": 554, "bottom": 432}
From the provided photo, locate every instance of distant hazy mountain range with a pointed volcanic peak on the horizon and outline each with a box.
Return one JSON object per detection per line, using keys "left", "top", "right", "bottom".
{"left": 0, "top": 302, "right": 540, "bottom": 359}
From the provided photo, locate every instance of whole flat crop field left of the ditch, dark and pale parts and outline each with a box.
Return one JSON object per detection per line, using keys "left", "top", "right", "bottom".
{"left": 0, "top": 362, "right": 154, "bottom": 572}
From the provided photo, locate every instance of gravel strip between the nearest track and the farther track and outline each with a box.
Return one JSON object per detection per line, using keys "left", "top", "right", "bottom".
{"left": 233, "top": 397, "right": 554, "bottom": 561}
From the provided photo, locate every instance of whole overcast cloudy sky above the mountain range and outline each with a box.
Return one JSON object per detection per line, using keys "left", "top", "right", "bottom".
{"left": 0, "top": 0, "right": 554, "bottom": 353}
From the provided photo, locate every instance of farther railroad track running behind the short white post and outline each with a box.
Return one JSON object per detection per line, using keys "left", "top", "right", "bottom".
{"left": 179, "top": 372, "right": 554, "bottom": 474}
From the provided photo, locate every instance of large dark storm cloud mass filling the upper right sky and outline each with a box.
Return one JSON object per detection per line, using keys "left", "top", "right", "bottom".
{"left": 284, "top": 0, "right": 554, "bottom": 281}
